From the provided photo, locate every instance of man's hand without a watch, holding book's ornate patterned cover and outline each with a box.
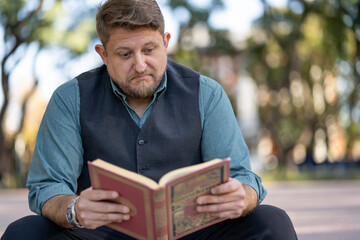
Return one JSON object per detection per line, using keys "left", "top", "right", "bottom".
{"left": 196, "top": 178, "right": 257, "bottom": 219}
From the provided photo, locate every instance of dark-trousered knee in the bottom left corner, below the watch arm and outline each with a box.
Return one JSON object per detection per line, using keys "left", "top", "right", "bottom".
{"left": 1, "top": 215, "right": 62, "bottom": 240}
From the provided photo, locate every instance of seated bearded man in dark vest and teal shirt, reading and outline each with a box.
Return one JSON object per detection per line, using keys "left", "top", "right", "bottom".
{"left": 3, "top": 0, "right": 296, "bottom": 240}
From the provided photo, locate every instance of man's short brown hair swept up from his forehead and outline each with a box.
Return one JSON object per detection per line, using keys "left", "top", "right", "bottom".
{"left": 96, "top": 0, "right": 165, "bottom": 46}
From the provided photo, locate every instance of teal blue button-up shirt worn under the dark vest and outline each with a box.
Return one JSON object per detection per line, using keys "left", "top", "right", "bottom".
{"left": 26, "top": 71, "right": 266, "bottom": 215}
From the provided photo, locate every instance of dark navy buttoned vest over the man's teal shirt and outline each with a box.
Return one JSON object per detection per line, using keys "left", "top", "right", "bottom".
{"left": 77, "top": 61, "right": 202, "bottom": 192}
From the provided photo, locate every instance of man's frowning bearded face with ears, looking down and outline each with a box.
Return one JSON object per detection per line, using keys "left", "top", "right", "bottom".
{"left": 95, "top": 28, "right": 170, "bottom": 99}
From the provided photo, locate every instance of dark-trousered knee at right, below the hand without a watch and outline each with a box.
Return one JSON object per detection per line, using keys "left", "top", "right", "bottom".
{"left": 250, "top": 205, "right": 297, "bottom": 240}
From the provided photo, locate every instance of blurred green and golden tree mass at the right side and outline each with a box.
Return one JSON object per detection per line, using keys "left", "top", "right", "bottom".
{"left": 247, "top": 0, "right": 360, "bottom": 169}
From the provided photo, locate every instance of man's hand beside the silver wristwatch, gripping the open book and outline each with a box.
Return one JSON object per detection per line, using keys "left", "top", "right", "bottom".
{"left": 75, "top": 187, "right": 130, "bottom": 229}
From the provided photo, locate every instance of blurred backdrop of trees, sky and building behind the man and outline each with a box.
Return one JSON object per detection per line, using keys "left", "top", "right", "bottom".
{"left": 0, "top": 0, "right": 360, "bottom": 188}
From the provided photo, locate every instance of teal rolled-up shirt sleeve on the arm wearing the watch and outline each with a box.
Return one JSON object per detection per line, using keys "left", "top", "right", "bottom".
{"left": 26, "top": 79, "right": 83, "bottom": 215}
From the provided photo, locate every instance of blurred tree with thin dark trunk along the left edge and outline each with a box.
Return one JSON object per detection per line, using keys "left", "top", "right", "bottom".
{"left": 0, "top": 0, "right": 95, "bottom": 187}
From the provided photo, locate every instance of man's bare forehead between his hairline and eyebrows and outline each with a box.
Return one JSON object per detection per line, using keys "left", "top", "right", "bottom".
{"left": 106, "top": 28, "right": 163, "bottom": 49}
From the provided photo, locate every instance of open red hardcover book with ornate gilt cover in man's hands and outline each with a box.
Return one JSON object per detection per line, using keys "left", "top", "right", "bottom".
{"left": 88, "top": 159, "right": 230, "bottom": 240}
